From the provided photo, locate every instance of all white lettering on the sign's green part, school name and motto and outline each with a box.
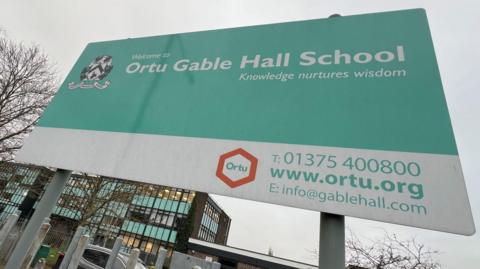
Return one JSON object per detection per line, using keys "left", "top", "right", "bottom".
{"left": 125, "top": 45, "right": 407, "bottom": 82}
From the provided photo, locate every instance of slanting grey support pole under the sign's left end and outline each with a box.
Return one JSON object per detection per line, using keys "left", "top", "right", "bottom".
{"left": 5, "top": 169, "right": 72, "bottom": 269}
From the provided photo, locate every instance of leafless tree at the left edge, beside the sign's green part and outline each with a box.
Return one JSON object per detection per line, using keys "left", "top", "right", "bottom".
{"left": 0, "top": 29, "right": 58, "bottom": 160}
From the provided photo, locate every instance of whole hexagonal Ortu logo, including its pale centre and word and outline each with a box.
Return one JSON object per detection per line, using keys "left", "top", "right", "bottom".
{"left": 216, "top": 148, "right": 258, "bottom": 188}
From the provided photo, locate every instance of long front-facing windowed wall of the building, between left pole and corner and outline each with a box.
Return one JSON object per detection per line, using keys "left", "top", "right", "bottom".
{"left": 53, "top": 174, "right": 195, "bottom": 261}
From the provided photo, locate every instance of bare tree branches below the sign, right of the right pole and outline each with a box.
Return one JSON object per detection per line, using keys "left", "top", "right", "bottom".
{"left": 345, "top": 228, "right": 441, "bottom": 269}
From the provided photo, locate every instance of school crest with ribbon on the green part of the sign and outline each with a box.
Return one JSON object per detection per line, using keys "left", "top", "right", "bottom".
{"left": 68, "top": 55, "right": 113, "bottom": 90}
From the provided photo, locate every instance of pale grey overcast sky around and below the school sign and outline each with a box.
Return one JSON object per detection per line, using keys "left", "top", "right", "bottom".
{"left": 0, "top": 0, "right": 480, "bottom": 269}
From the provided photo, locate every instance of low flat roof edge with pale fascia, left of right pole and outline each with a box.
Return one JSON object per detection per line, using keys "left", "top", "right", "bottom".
{"left": 188, "top": 238, "right": 318, "bottom": 269}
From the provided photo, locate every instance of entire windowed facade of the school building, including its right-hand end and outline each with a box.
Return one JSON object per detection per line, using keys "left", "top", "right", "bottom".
{"left": 0, "top": 163, "right": 229, "bottom": 264}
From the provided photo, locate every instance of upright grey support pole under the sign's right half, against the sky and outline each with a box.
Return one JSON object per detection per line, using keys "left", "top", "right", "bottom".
{"left": 318, "top": 213, "right": 345, "bottom": 269}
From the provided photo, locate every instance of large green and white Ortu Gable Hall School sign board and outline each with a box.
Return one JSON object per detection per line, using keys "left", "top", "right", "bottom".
{"left": 17, "top": 9, "right": 475, "bottom": 234}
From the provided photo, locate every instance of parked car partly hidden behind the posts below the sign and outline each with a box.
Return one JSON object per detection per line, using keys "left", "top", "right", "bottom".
{"left": 78, "top": 245, "right": 146, "bottom": 269}
